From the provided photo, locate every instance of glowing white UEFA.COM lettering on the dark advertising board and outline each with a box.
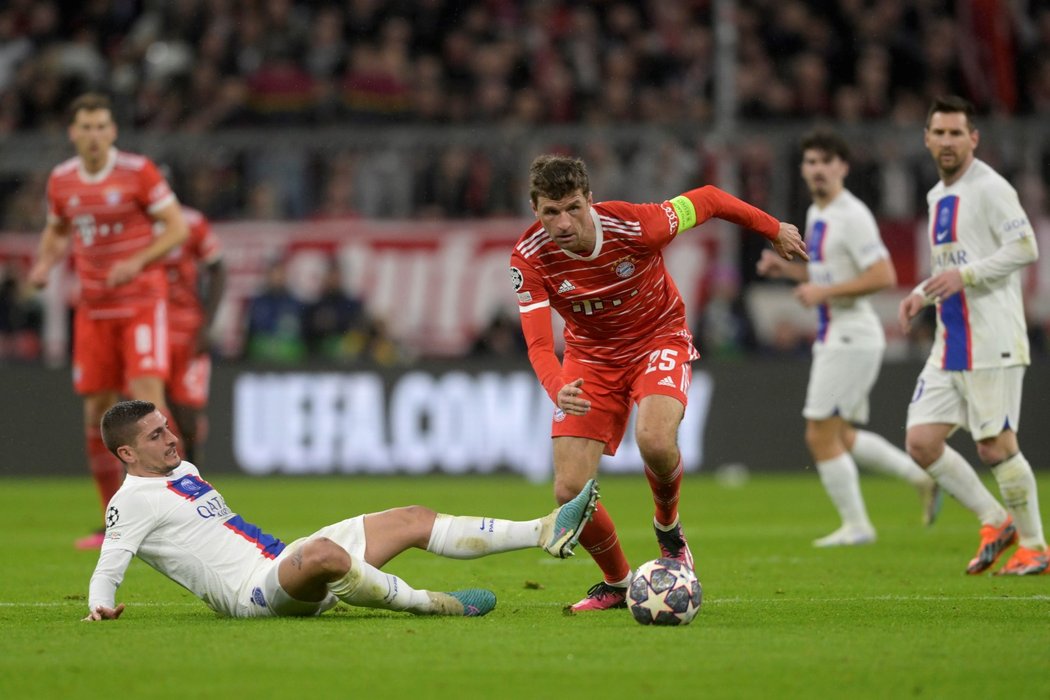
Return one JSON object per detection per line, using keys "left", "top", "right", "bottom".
{"left": 233, "top": 372, "right": 712, "bottom": 481}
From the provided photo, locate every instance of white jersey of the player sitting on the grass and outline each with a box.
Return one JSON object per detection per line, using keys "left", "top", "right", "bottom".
{"left": 102, "top": 462, "right": 285, "bottom": 615}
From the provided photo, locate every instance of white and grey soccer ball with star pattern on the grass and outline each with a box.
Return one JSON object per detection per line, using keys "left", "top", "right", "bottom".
{"left": 627, "top": 558, "right": 704, "bottom": 624}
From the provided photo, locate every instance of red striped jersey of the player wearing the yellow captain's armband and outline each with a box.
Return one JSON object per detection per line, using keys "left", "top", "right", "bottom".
{"left": 510, "top": 201, "right": 690, "bottom": 365}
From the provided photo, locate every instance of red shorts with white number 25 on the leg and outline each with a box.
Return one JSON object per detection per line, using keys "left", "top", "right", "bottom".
{"left": 550, "top": 337, "right": 699, "bottom": 454}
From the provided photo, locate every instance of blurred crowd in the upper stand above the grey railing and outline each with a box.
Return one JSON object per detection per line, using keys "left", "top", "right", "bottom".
{"left": 6, "top": 0, "right": 1050, "bottom": 131}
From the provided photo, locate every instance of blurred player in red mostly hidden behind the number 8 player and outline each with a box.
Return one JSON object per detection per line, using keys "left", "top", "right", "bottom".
{"left": 155, "top": 206, "right": 226, "bottom": 464}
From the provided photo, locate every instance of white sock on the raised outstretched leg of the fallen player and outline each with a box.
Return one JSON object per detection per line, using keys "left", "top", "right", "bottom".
{"left": 426, "top": 513, "right": 549, "bottom": 559}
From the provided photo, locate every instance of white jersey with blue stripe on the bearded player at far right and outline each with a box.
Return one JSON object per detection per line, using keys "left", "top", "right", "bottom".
{"left": 926, "top": 160, "right": 1034, "bottom": 370}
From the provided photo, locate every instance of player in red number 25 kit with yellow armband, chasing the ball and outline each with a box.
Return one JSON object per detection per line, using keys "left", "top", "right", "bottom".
{"left": 510, "top": 155, "right": 809, "bottom": 612}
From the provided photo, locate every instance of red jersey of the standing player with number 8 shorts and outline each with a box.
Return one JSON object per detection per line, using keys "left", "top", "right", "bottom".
{"left": 47, "top": 148, "right": 175, "bottom": 307}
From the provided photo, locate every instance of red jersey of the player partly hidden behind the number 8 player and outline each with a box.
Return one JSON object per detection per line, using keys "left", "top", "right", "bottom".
{"left": 161, "top": 206, "right": 222, "bottom": 343}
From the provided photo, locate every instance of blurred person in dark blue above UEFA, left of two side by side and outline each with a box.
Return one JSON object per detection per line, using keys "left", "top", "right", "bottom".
{"left": 245, "top": 260, "right": 306, "bottom": 363}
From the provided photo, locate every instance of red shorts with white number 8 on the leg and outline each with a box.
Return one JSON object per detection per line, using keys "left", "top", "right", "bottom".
{"left": 72, "top": 300, "right": 169, "bottom": 395}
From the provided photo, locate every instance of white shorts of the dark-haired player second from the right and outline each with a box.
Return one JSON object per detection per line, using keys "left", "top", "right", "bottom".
{"left": 802, "top": 343, "right": 883, "bottom": 424}
